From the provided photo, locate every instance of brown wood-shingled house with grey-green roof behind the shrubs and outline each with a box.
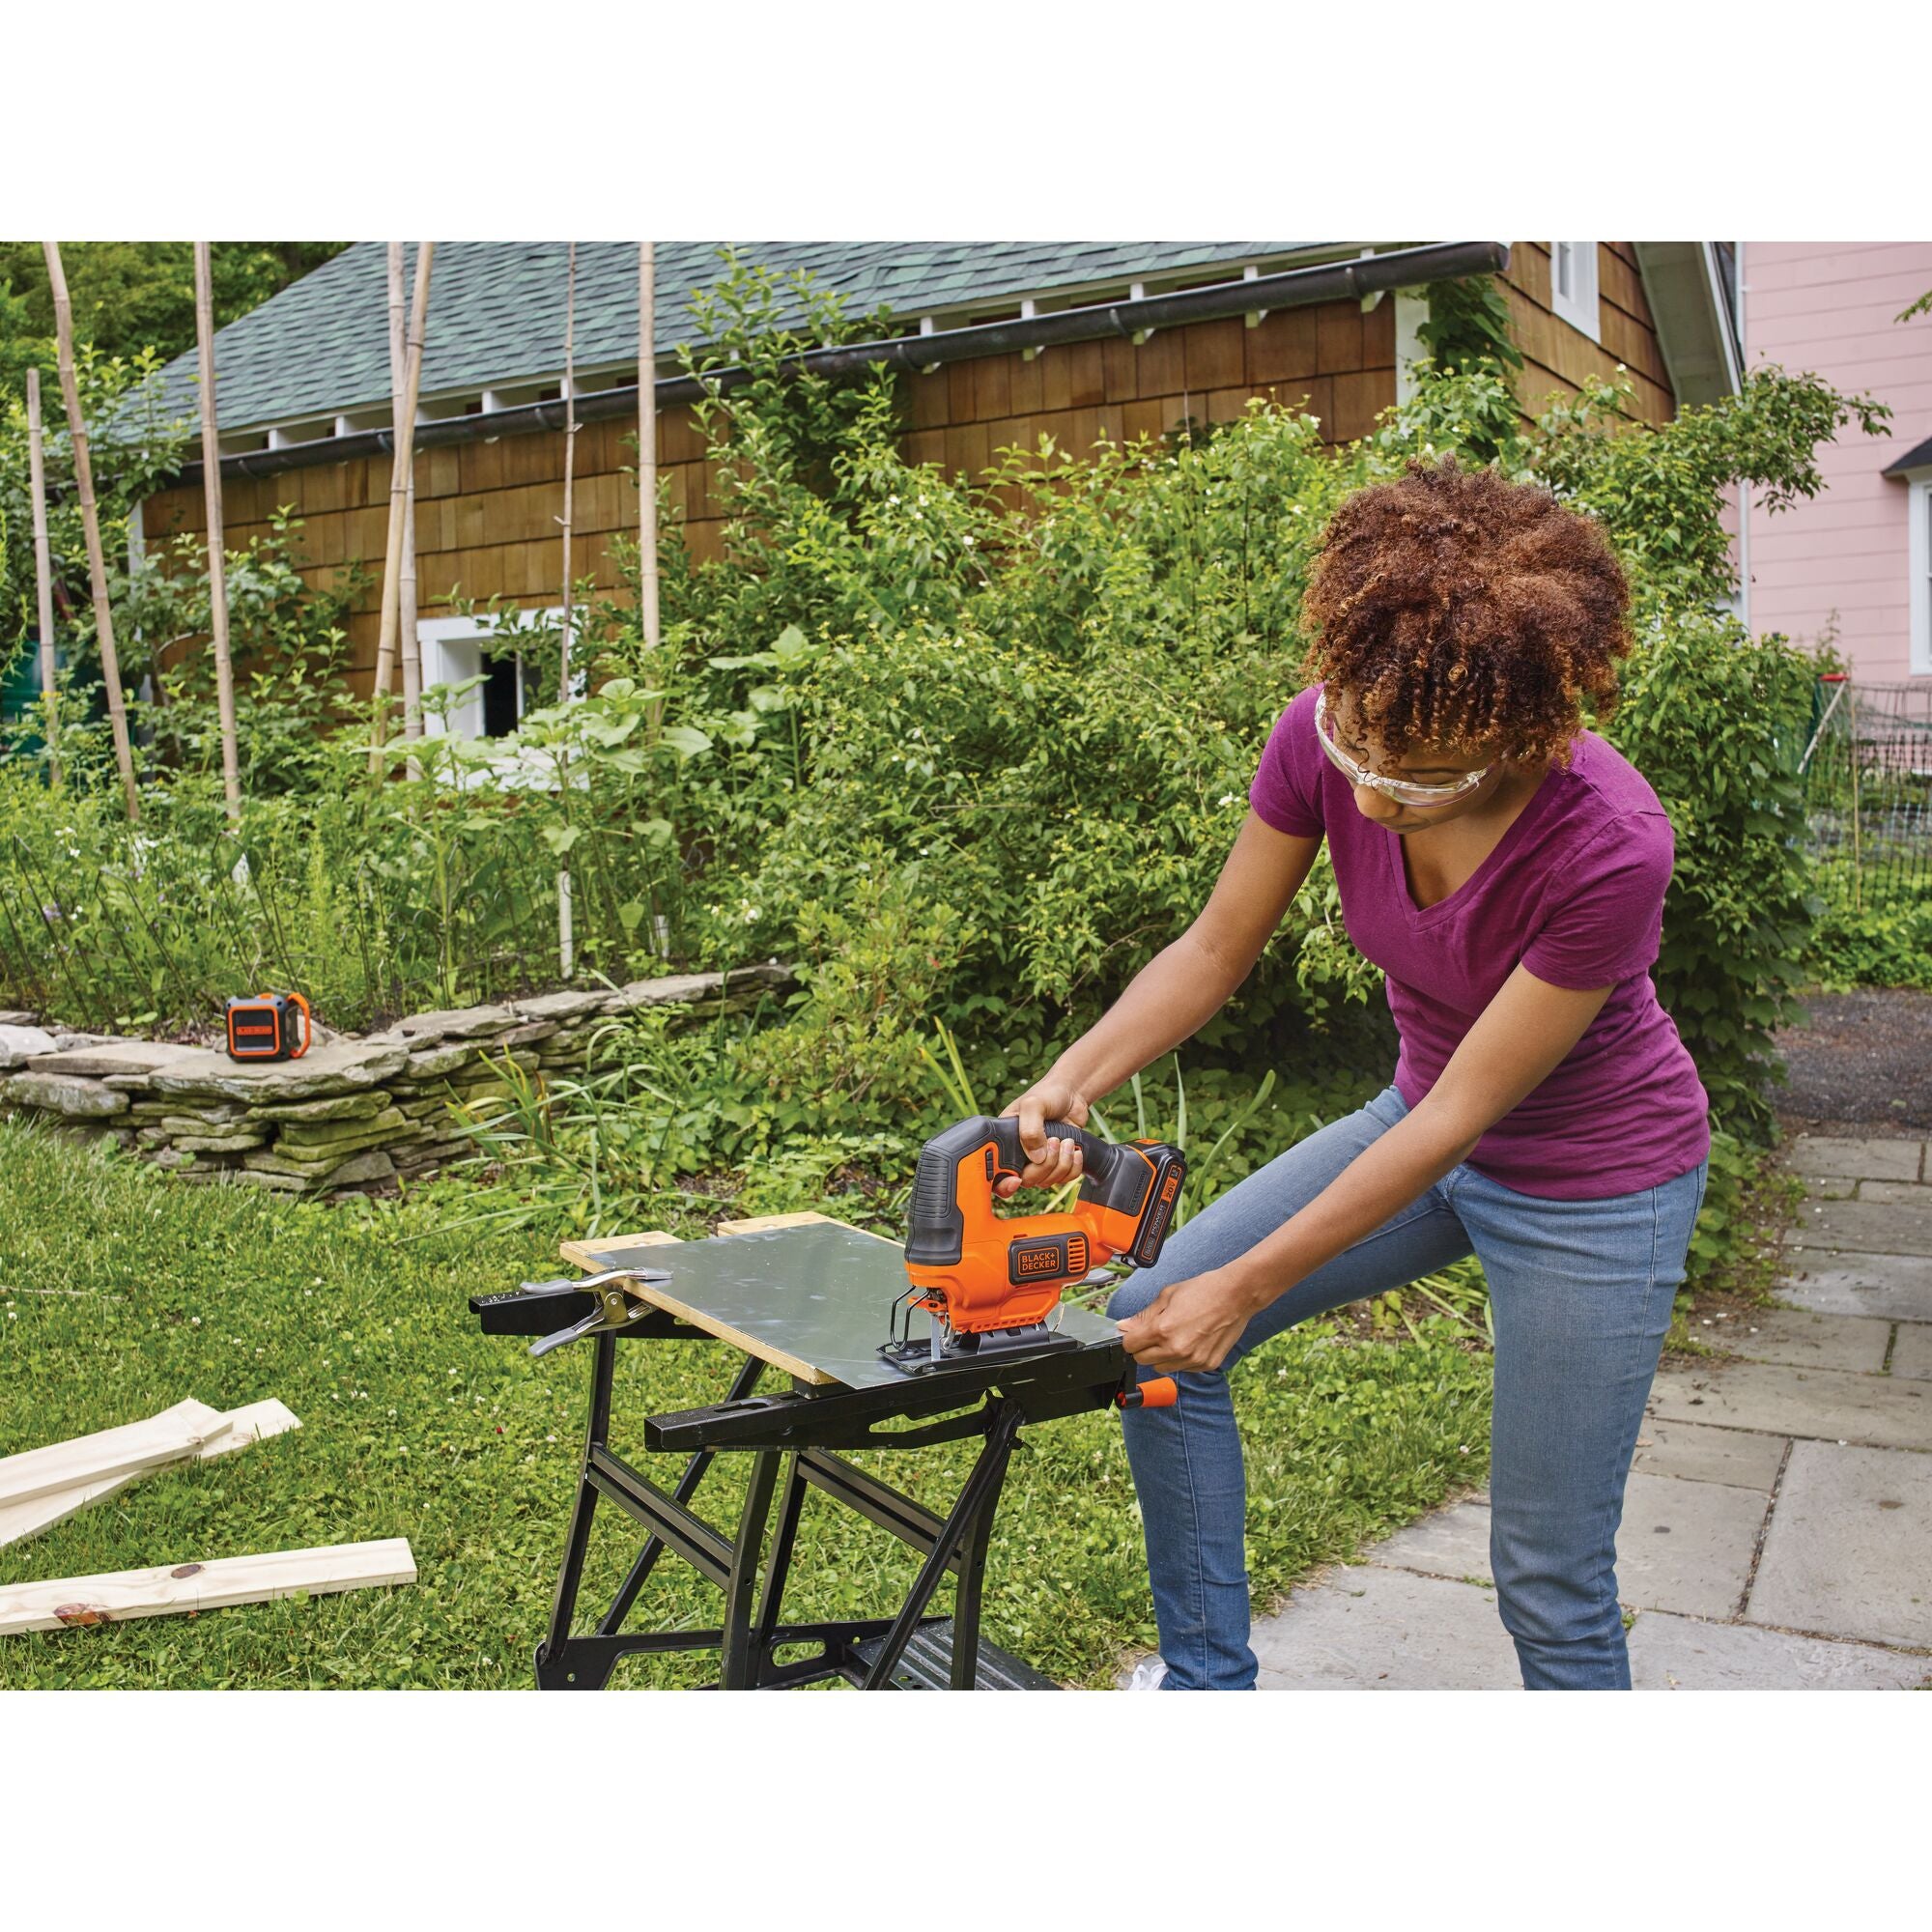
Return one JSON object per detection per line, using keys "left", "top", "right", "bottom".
{"left": 141, "top": 242, "right": 1737, "bottom": 734}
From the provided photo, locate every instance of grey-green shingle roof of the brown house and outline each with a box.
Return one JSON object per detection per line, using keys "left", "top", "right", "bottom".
{"left": 147, "top": 242, "right": 1321, "bottom": 431}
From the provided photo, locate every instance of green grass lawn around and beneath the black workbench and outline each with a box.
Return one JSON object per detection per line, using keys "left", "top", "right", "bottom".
{"left": 0, "top": 1122, "right": 1490, "bottom": 1689}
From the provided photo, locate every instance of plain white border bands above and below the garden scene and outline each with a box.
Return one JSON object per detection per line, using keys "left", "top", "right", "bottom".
{"left": 0, "top": 0, "right": 1932, "bottom": 1932}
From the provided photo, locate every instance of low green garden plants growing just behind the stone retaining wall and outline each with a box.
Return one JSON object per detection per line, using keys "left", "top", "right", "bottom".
{"left": 0, "top": 738, "right": 688, "bottom": 1032}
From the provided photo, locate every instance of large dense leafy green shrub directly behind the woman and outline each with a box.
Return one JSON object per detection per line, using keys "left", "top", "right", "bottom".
{"left": 641, "top": 284, "right": 1884, "bottom": 1134}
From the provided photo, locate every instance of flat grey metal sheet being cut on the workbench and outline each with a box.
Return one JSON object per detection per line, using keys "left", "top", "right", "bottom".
{"left": 601, "top": 1225, "right": 1121, "bottom": 1389}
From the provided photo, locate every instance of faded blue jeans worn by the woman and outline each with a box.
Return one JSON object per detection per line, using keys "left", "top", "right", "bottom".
{"left": 1107, "top": 1086, "right": 1708, "bottom": 1690}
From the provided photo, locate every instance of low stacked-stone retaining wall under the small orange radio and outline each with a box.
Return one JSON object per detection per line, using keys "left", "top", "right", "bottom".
{"left": 0, "top": 962, "right": 792, "bottom": 1194}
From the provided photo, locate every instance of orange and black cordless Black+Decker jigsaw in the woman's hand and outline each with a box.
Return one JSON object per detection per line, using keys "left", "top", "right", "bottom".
{"left": 879, "top": 1115, "right": 1186, "bottom": 1376}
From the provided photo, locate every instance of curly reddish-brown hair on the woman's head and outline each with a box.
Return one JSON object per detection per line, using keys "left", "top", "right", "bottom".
{"left": 1302, "top": 456, "right": 1631, "bottom": 763}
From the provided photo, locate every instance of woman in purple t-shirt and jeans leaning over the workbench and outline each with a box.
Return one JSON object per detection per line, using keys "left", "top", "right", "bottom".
{"left": 1001, "top": 462, "right": 1710, "bottom": 1690}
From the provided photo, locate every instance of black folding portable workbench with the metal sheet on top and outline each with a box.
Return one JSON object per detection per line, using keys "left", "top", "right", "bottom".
{"left": 469, "top": 1215, "right": 1130, "bottom": 1690}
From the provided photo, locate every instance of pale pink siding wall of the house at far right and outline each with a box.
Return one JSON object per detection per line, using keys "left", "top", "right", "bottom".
{"left": 1741, "top": 242, "right": 1932, "bottom": 680}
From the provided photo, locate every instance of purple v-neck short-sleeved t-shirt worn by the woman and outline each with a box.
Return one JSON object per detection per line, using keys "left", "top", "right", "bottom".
{"left": 1248, "top": 686, "right": 1710, "bottom": 1200}
